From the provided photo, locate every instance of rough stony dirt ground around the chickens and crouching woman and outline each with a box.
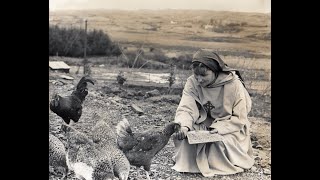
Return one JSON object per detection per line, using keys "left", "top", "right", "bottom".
{"left": 49, "top": 73, "right": 271, "bottom": 180}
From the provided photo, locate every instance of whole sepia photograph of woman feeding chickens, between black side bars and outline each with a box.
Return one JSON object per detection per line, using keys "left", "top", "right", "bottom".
{"left": 49, "top": 0, "right": 271, "bottom": 180}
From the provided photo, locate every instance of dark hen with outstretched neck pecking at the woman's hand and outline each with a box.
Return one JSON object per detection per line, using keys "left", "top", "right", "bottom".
{"left": 116, "top": 118, "right": 180, "bottom": 179}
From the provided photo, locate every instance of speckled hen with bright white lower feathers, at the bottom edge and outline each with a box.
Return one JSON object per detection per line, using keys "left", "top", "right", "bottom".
{"left": 61, "top": 124, "right": 115, "bottom": 180}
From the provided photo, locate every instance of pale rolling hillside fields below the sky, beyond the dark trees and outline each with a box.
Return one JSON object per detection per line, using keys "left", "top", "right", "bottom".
{"left": 49, "top": 9, "right": 271, "bottom": 57}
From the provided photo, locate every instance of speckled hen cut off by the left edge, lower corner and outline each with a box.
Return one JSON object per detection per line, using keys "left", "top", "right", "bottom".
{"left": 49, "top": 133, "right": 68, "bottom": 179}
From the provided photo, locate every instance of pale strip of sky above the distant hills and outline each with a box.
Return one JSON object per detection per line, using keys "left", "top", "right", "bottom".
{"left": 49, "top": 0, "right": 271, "bottom": 13}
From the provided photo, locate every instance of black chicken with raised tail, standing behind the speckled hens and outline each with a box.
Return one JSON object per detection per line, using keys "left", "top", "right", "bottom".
{"left": 50, "top": 76, "right": 94, "bottom": 124}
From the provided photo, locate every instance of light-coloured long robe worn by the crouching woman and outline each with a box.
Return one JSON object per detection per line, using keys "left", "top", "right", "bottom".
{"left": 172, "top": 72, "right": 254, "bottom": 177}
